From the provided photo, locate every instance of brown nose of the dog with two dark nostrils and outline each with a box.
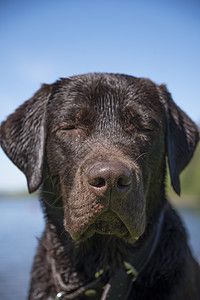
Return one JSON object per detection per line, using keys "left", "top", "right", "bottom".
{"left": 87, "top": 161, "right": 132, "bottom": 195}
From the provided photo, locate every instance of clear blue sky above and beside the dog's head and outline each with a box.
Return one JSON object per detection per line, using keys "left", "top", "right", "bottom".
{"left": 0, "top": 0, "right": 200, "bottom": 190}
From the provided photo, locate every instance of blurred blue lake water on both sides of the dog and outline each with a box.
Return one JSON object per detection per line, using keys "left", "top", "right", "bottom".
{"left": 0, "top": 197, "right": 200, "bottom": 300}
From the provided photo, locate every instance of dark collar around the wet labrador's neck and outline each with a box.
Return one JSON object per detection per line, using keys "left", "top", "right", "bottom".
{"left": 50, "top": 208, "right": 166, "bottom": 300}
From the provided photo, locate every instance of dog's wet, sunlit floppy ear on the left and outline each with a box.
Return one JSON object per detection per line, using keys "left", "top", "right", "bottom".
{"left": 0, "top": 84, "right": 51, "bottom": 193}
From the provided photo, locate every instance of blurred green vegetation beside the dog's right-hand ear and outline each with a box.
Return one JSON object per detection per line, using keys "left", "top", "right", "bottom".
{"left": 166, "top": 143, "right": 200, "bottom": 207}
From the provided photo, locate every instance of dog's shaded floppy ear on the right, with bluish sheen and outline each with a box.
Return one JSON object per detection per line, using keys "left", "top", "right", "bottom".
{"left": 159, "top": 85, "right": 199, "bottom": 195}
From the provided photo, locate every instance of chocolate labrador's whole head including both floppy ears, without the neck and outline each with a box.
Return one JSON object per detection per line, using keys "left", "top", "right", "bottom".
{"left": 0, "top": 74, "right": 199, "bottom": 242}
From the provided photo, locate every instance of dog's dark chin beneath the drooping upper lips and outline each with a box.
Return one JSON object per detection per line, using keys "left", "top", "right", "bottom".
{"left": 71, "top": 212, "right": 138, "bottom": 243}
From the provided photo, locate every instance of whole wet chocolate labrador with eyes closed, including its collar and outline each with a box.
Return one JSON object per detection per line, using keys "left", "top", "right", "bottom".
{"left": 0, "top": 73, "right": 200, "bottom": 300}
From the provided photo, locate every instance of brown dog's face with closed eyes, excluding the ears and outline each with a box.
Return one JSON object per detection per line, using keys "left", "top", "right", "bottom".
{"left": 46, "top": 77, "right": 165, "bottom": 241}
